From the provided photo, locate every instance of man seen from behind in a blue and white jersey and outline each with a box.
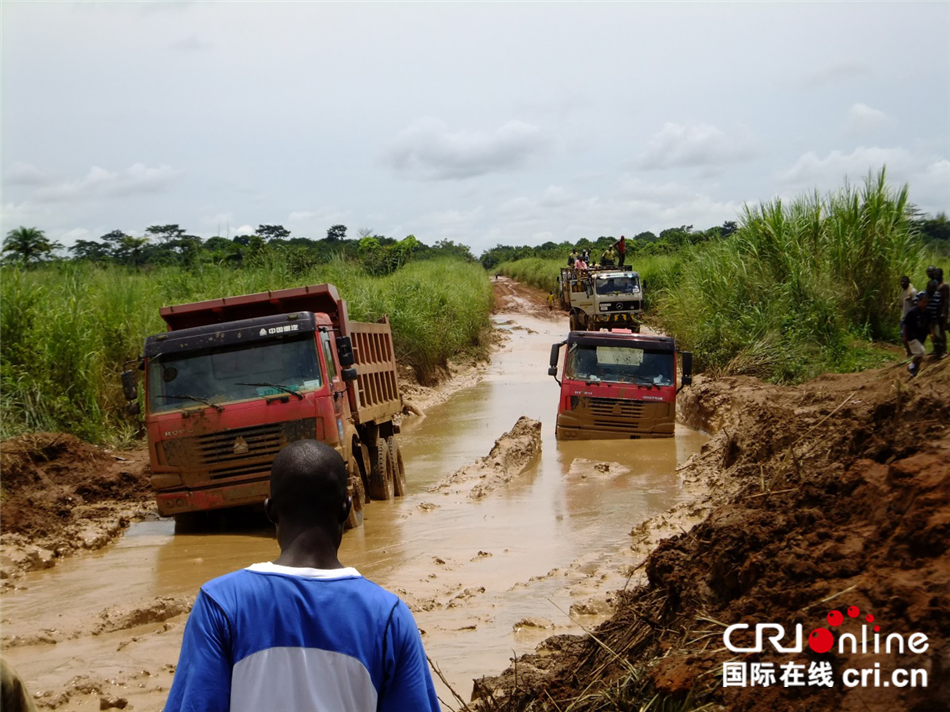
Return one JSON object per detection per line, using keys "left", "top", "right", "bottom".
{"left": 165, "top": 440, "right": 440, "bottom": 712}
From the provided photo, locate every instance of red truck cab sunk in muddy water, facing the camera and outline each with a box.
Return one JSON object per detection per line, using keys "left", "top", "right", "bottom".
{"left": 548, "top": 331, "right": 692, "bottom": 440}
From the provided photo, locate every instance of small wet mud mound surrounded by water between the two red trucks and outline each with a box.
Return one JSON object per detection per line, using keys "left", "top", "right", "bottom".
{"left": 429, "top": 416, "right": 541, "bottom": 500}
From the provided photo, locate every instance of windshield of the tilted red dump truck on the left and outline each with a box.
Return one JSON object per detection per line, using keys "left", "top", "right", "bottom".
{"left": 148, "top": 334, "right": 323, "bottom": 413}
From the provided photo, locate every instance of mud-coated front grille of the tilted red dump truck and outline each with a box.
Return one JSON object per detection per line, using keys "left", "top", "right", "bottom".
{"left": 162, "top": 418, "right": 322, "bottom": 484}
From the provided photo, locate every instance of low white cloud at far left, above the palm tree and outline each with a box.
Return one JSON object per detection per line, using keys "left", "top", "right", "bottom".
{"left": 33, "top": 163, "right": 183, "bottom": 203}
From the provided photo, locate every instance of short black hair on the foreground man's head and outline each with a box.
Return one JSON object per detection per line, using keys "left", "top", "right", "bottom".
{"left": 270, "top": 440, "right": 347, "bottom": 524}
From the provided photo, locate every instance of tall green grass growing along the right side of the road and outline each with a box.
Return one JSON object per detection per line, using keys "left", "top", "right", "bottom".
{"left": 495, "top": 171, "right": 948, "bottom": 382}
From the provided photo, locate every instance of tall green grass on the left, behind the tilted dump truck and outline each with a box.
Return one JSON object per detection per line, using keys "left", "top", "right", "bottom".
{"left": 0, "top": 258, "right": 492, "bottom": 443}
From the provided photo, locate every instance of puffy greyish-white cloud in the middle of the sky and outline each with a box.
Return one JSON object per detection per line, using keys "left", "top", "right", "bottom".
{"left": 386, "top": 118, "right": 547, "bottom": 180}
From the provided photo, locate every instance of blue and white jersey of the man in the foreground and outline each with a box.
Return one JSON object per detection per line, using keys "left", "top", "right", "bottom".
{"left": 165, "top": 563, "right": 440, "bottom": 712}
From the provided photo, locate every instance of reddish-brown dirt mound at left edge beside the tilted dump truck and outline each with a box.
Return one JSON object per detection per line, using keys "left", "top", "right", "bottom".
{"left": 0, "top": 433, "right": 151, "bottom": 579}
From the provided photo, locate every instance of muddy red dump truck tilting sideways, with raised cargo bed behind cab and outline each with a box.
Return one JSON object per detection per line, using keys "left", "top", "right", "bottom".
{"left": 122, "top": 284, "right": 406, "bottom": 527}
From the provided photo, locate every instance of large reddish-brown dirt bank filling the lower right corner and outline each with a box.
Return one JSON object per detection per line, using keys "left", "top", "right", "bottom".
{"left": 476, "top": 359, "right": 950, "bottom": 710}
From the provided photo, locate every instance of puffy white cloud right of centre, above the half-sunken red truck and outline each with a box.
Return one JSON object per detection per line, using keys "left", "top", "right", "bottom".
{"left": 636, "top": 123, "right": 756, "bottom": 170}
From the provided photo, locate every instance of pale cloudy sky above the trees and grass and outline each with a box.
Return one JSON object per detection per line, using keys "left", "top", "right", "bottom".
{"left": 0, "top": 0, "right": 950, "bottom": 254}
